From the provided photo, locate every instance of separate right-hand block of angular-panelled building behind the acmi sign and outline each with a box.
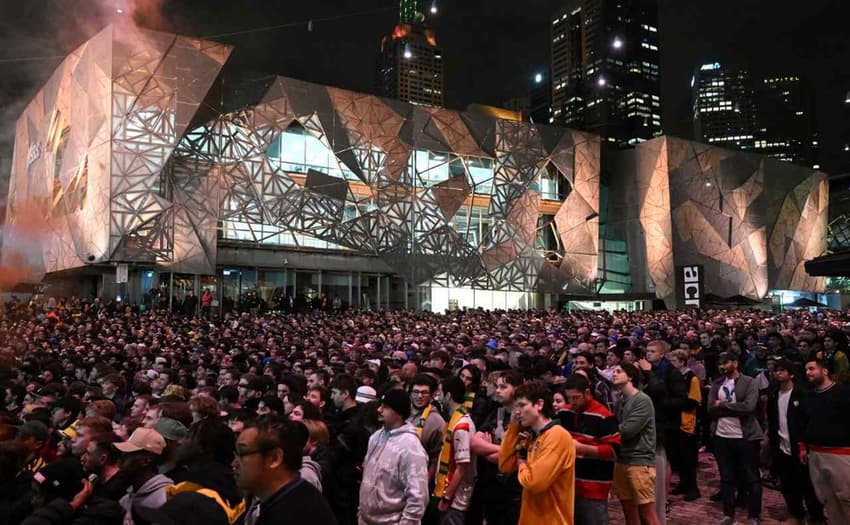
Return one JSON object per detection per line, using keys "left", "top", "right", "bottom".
{"left": 613, "top": 137, "right": 829, "bottom": 307}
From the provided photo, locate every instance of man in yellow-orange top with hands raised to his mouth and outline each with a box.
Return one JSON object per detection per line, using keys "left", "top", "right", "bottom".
{"left": 499, "top": 382, "right": 576, "bottom": 525}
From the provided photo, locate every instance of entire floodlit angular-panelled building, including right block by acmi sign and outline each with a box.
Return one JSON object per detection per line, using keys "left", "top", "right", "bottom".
{"left": 0, "top": 27, "right": 828, "bottom": 310}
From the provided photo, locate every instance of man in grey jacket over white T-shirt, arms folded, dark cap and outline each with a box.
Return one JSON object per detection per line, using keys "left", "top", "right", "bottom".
{"left": 708, "top": 351, "right": 762, "bottom": 525}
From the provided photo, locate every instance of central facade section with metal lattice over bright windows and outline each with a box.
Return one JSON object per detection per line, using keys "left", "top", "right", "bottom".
{"left": 169, "top": 77, "right": 599, "bottom": 290}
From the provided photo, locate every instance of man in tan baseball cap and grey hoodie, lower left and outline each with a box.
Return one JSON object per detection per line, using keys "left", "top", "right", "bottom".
{"left": 112, "top": 428, "right": 174, "bottom": 525}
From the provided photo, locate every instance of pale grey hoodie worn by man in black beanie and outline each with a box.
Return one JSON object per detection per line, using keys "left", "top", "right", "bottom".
{"left": 359, "top": 423, "right": 428, "bottom": 525}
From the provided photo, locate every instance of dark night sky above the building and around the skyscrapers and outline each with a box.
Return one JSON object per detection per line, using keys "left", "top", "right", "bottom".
{"left": 0, "top": 0, "right": 850, "bottom": 173}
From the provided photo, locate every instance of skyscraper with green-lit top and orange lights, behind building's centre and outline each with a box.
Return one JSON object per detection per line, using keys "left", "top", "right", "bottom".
{"left": 377, "top": 0, "right": 443, "bottom": 106}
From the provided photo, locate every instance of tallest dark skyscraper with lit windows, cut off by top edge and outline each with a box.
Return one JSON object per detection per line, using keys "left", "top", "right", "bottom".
{"left": 551, "top": 0, "right": 661, "bottom": 146}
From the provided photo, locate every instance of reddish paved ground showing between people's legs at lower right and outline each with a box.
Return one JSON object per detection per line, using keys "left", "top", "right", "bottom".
{"left": 608, "top": 452, "right": 788, "bottom": 525}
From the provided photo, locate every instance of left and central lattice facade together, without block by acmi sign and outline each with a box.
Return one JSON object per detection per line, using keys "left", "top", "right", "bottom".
{"left": 4, "top": 27, "right": 599, "bottom": 291}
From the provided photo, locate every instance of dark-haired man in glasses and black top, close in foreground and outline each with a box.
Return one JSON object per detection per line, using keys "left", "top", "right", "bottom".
{"left": 236, "top": 416, "right": 336, "bottom": 525}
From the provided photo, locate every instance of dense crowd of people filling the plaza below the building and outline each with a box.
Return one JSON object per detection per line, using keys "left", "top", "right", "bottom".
{"left": 0, "top": 299, "right": 850, "bottom": 525}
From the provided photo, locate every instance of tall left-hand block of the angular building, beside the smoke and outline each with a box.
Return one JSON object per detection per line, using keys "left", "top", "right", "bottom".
{"left": 3, "top": 26, "right": 231, "bottom": 276}
